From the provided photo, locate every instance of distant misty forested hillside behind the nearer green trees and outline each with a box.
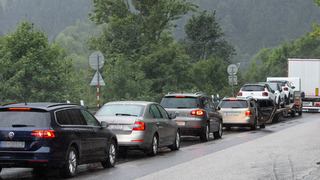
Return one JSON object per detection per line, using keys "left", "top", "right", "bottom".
{"left": 0, "top": 0, "right": 320, "bottom": 68}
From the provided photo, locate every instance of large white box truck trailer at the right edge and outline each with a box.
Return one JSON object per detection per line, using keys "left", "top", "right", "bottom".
{"left": 288, "top": 58, "right": 320, "bottom": 112}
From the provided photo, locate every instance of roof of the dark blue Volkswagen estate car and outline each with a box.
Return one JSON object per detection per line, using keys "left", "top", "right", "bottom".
{"left": 0, "top": 102, "right": 81, "bottom": 111}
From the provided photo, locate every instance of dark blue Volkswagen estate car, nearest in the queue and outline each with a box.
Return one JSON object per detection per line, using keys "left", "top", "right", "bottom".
{"left": 0, "top": 103, "right": 118, "bottom": 177}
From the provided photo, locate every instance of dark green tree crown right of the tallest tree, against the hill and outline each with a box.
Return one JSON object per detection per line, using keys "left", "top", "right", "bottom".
{"left": 182, "top": 10, "right": 235, "bottom": 62}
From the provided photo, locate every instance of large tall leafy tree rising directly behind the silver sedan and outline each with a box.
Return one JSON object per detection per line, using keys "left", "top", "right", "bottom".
{"left": 89, "top": 0, "right": 197, "bottom": 101}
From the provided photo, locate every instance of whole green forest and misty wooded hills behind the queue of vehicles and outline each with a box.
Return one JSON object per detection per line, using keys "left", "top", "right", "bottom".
{"left": 0, "top": 0, "right": 320, "bottom": 106}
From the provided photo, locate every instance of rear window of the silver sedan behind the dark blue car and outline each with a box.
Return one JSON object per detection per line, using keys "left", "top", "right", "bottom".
{"left": 95, "top": 104, "right": 144, "bottom": 116}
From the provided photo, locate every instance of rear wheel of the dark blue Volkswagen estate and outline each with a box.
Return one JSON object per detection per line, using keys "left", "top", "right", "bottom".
{"left": 62, "top": 146, "right": 78, "bottom": 178}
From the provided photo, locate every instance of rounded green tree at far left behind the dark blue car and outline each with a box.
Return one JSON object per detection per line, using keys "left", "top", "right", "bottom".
{"left": 0, "top": 21, "right": 77, "bottom": 103}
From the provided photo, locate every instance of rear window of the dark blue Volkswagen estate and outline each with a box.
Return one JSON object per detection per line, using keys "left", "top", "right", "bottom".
{"left": 0, "top": 111, "right": 50, "bottom": 127}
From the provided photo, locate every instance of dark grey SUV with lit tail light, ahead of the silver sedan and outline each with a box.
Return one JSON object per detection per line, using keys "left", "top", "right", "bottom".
{"left": 160, "top": 93, "right": 222, "bottom": 141}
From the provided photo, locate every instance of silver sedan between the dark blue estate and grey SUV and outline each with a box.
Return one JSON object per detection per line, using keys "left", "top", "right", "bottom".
{"left": 95, "top": 101, "right": 180, "bottom": 156}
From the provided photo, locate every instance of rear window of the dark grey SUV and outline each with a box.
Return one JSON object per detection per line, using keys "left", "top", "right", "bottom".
{"left": 161, "top": 97, "right": 198, "bottom": 108}
